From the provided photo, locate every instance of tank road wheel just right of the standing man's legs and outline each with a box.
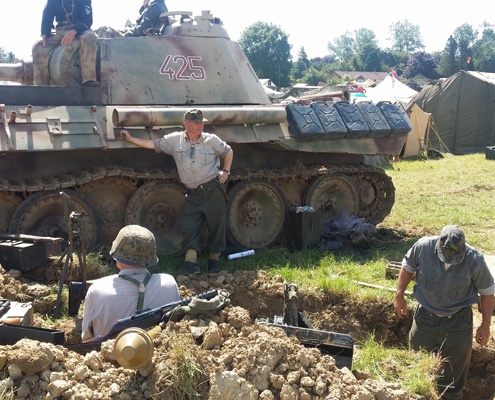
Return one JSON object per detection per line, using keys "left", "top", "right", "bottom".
{"left": 227, "top": 179, "right": 287, "bottom": 249}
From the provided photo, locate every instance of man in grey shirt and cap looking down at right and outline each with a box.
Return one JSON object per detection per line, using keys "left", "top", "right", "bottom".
{"left": 394, "top": 225, "right": 495, "bottom": 399}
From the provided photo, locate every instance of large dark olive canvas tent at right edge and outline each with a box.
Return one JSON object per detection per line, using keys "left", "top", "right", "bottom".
{"left": 412, "top": 71, "right": 495, "bottom": 154}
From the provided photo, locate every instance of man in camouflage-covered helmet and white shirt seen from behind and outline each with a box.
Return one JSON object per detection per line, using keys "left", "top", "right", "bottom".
{"left": 82, "top": 225, "right": 180, "bottom": 342}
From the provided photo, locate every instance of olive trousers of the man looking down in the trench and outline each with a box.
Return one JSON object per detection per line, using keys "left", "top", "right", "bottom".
{"left": 409, "top": 305, "right": 473, "bottom": 399}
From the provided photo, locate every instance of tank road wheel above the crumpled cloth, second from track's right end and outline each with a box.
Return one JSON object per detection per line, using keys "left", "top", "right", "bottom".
{"left": 304, "top": 175, "right": 358, "bottom": 224}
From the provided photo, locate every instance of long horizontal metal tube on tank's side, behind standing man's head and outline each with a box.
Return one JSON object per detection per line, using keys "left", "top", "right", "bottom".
{"left": 112, "top": 106, "right": 287, "bottom": 127}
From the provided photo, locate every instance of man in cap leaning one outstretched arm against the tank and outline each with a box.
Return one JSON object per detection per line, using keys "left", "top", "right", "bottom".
{"left": 121, "top": 109, "right": 234, "bottom": 274}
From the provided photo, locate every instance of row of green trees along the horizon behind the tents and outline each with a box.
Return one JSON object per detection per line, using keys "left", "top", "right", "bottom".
{"left": 239, "top": 20, "right": 495, "bottom": 87}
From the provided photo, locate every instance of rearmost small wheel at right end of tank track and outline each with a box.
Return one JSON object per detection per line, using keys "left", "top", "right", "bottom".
{"left": 355, "top": 172, "right": 395, "bottom": 225}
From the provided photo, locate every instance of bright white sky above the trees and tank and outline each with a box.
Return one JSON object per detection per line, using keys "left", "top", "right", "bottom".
{"left": 0, "top": 0, "right": 495, "bottom": 61}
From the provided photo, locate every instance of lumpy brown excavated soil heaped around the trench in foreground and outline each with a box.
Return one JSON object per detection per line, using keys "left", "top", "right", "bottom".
{"left": 0, "top": 269, "right": 495, "bottom": 400}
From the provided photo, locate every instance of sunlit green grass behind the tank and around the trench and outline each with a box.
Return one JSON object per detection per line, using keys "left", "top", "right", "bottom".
{"left": 45, "top": 154, "right": 495, "bottom": 398}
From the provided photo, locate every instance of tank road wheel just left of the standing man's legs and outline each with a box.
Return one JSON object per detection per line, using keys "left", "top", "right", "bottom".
{"left": 125, "top": 180, "right": 186, "bottom": 254}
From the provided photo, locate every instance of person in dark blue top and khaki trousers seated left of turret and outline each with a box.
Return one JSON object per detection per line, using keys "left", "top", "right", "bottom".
{"left": 33, "top": 0, "right": 100, "bottom": 87}
